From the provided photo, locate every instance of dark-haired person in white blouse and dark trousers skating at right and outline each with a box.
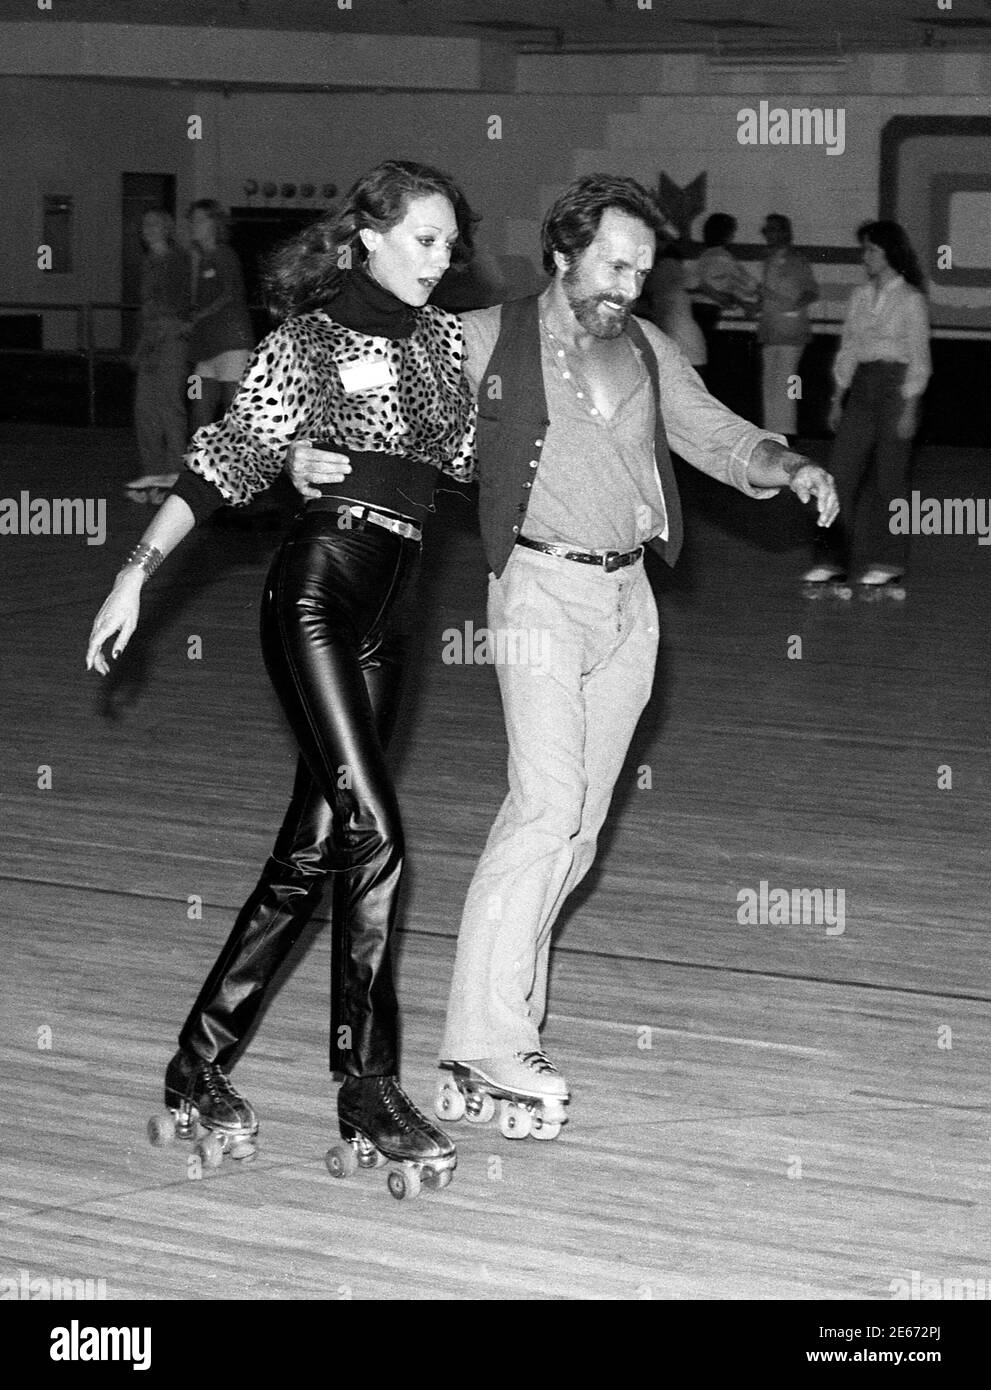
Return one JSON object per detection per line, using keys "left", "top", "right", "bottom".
{"left": 803, "top": 221, "right": 933, "bottom": 585}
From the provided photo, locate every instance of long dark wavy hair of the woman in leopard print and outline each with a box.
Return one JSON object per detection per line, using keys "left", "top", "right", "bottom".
{"left": 263, "top": 160, "right": 478, "bottom": 320}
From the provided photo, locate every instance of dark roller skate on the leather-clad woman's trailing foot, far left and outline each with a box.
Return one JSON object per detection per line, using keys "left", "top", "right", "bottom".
{"left": 147, "top": 1051, "right": 259, "bottom": 1168}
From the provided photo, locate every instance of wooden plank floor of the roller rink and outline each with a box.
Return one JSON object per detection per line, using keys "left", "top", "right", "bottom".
{"left": 0, "top": 425, "right": 991, "bottom": 1300}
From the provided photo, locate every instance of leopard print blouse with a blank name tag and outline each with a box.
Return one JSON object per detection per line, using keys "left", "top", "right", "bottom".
{"left": 186, "top": 304, "right": 475, "bottom": 506}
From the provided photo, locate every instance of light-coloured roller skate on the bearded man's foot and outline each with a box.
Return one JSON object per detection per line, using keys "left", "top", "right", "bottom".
{"left": 434, "top": 1052, "right": 570, "bottom": 1140}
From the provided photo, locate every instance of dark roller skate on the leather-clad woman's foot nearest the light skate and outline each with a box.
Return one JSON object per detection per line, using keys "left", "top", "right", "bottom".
{"left": 327, "top": 1076, "right": 457, "bottom": 1201}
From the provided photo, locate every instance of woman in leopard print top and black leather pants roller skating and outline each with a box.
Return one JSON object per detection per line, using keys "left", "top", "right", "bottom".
{"left": 86, "top": 161, "right": 474, "bottom": 1197}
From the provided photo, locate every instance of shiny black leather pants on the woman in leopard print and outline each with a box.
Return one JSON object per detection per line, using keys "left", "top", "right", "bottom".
{"left": 179, "top": 510, "right": 420, "bottom": 1076}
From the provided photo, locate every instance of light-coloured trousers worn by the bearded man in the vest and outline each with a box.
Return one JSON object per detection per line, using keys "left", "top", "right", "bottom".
{"left": 442, "top": 546, "right": 657, "bottom": 1062}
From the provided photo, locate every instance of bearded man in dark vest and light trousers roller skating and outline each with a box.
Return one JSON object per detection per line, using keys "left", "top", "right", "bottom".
{"left": 436, "top": 175, "right": 837, "bottom": 1137}
